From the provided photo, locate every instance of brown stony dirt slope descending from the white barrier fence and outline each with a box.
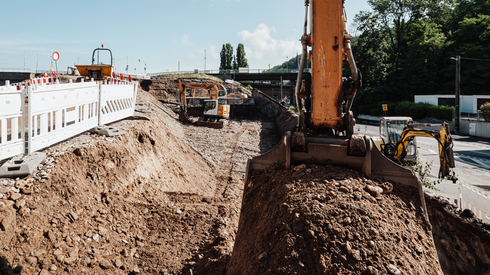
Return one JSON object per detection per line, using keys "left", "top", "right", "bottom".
{"left": 0, "top": 84, "right": 275, "bottom": 274}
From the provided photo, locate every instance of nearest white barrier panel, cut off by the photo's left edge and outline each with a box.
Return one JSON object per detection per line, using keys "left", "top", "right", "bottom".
{"left": 0, "top": 81, "right": 26, "bottom": 160}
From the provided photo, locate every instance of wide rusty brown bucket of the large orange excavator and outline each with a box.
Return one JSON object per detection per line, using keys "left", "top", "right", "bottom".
{"left": 245, "top": 132, "right": 427, "bottom": 217}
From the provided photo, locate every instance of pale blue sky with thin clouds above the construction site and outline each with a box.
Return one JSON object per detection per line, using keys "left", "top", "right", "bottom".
{"left": 0, "top": 0, "right": 370, "bottom": 73}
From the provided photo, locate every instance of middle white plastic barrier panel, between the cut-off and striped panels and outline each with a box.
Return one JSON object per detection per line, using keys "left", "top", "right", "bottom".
{"left": 27, "top": 82, "right": 99, "bottom": 153}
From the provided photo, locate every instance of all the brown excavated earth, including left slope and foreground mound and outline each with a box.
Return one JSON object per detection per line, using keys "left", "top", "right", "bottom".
{"left": 0, "top": 76, "right": 490, "bottom": 274}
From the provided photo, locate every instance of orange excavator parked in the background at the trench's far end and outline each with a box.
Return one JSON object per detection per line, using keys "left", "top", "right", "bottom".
{"left": 179, "top": 79, "right": 230, "bottom": 129}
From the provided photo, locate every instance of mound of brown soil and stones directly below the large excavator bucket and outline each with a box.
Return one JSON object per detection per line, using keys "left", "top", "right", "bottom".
{"left": 228, "top": 165, "right": 442, "bottom": 274}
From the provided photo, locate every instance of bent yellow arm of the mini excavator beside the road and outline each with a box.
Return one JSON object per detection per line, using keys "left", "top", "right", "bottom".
{"left": 392, "top": 123, "right": 455, "bottom": 178}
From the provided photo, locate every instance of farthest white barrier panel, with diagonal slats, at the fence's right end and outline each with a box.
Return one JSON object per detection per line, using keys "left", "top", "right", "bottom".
{"left": 99, "top": 81, "right": 138, "bottom": 125}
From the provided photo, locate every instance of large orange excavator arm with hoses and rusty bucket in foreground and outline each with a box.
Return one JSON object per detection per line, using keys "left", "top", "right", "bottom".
{"left": 245, "top": 0, "right": 456, "bottom": 217}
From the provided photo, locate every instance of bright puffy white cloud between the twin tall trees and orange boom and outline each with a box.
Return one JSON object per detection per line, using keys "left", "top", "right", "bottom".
{"left": 238, "top": 24, "right": 301, "bottom": 60}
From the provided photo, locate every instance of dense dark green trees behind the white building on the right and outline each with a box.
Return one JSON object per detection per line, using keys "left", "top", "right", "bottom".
{"left": 352, "top": 0, "right": 490, "bottom": 115}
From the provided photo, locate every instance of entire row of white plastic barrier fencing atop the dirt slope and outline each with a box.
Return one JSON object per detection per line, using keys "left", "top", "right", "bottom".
{"left": 0, "top": 78, "right": 137, "bottom": 161}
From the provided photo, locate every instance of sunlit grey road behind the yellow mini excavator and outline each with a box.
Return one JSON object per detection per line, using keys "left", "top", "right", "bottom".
{"left": 355, "top": 124, "right": 490, "bottom": 195}
